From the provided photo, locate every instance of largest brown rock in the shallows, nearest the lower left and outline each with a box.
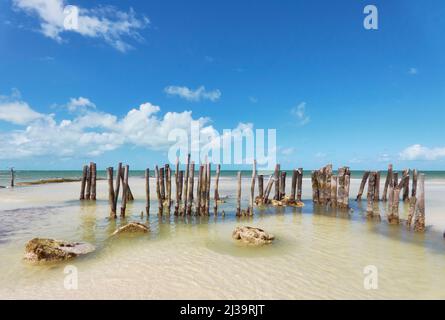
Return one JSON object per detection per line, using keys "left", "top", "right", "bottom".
{"left": 24, "top": 238, "right": 95, "bottom": 262}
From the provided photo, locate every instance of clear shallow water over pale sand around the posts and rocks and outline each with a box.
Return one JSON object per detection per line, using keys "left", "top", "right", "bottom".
{"left": 0, "top": 177, "right": 445, "bottom": 299}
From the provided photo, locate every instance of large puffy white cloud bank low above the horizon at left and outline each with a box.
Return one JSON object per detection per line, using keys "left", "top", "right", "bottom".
{"left": 0, "top": 94, "right": 215, "bottom": 159}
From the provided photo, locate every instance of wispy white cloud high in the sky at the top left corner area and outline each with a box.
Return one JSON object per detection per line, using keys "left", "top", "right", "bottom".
{"left": 13, "top": 0, "right": 149, "bottom": 52}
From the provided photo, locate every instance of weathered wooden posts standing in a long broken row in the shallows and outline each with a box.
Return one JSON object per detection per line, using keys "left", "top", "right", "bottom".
{"left": 80, "top": 160, "right": 425, "bottom": 231}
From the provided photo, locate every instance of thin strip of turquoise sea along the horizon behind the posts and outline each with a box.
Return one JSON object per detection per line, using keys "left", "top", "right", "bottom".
{"left": 0, "top": 169, "right": 445, "bottom": 186}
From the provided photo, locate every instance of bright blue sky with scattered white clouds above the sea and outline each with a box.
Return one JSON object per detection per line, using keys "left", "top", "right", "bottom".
{"left": 0, "top": 0, "right": 445, "bottom": 170}
